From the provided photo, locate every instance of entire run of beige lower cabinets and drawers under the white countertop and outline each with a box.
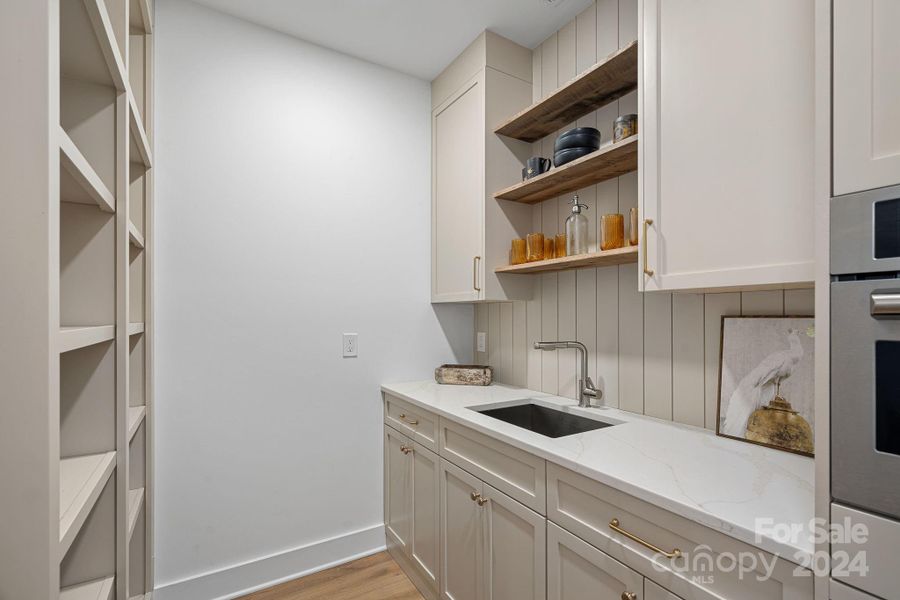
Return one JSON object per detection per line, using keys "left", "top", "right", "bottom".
{"left": 384, "top": 405, "right": 812, "bottom": 600}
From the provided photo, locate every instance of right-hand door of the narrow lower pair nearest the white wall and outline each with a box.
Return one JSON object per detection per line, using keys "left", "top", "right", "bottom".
{"left": 410, "top": 444, "right": 441, "bottom": 594}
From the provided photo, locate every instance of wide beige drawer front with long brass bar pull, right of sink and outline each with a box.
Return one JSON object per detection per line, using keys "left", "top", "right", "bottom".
{"left": 547, "top": 463, "right": 813, "bottom": 600}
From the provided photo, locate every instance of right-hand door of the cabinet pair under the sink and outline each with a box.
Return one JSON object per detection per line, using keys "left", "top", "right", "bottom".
{"left": 482, "top": 484, "right": 547, "bottom": 600}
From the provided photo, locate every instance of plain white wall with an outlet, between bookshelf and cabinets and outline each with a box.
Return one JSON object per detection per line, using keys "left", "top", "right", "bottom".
{"left": 154, "top": 0, "right": 473, "bottom": 600}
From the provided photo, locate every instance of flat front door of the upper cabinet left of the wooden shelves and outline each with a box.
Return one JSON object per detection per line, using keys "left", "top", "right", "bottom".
{"left": 431, "top": 74, "right": 484, "bottom": 302}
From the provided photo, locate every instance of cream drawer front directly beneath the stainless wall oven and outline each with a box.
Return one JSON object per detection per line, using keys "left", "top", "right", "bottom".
{"left": 831, "top": 504, "right": 900, "bottom": 600}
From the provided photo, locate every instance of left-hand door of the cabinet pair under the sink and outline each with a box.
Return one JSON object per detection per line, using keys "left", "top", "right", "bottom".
{"left": 440, "top": 459, "right": 484, "bottom": 600}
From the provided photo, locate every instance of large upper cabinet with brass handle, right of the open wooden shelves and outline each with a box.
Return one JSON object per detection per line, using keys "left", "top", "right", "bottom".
{"left": 638, "top": 0, "right": 814, "bottom": 291}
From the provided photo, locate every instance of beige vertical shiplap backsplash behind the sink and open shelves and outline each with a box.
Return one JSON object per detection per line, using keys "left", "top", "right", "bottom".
{"left": 475, "top": 0, "right": 813, "bottom": 429}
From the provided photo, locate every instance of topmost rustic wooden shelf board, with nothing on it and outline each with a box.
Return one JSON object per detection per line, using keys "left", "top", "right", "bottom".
{"left": 494, "top": 41, "right": 638, "bottom": 142}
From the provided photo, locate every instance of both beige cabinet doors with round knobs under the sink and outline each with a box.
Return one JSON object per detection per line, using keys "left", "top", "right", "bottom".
{"left": 441, "top": 459, "right": 547, "bottom": 600}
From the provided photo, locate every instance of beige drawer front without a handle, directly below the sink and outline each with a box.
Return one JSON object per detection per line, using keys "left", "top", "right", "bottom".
{"left": 440, "top": 419, "right": 547, "bottom": 515}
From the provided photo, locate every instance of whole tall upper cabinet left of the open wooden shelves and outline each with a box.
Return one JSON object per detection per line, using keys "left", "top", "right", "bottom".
{"left": 431, "top": 32, "right": 531, "bottom": 302}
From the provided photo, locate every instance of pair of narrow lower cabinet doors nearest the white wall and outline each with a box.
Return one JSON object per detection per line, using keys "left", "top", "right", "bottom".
{"left": 384, "top": 427, "right": 440, "bottom": 600}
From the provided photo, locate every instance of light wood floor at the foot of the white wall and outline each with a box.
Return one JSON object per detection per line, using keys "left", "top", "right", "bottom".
{"left": 240, "top": 552, "right": 423, "bottom": 600}
